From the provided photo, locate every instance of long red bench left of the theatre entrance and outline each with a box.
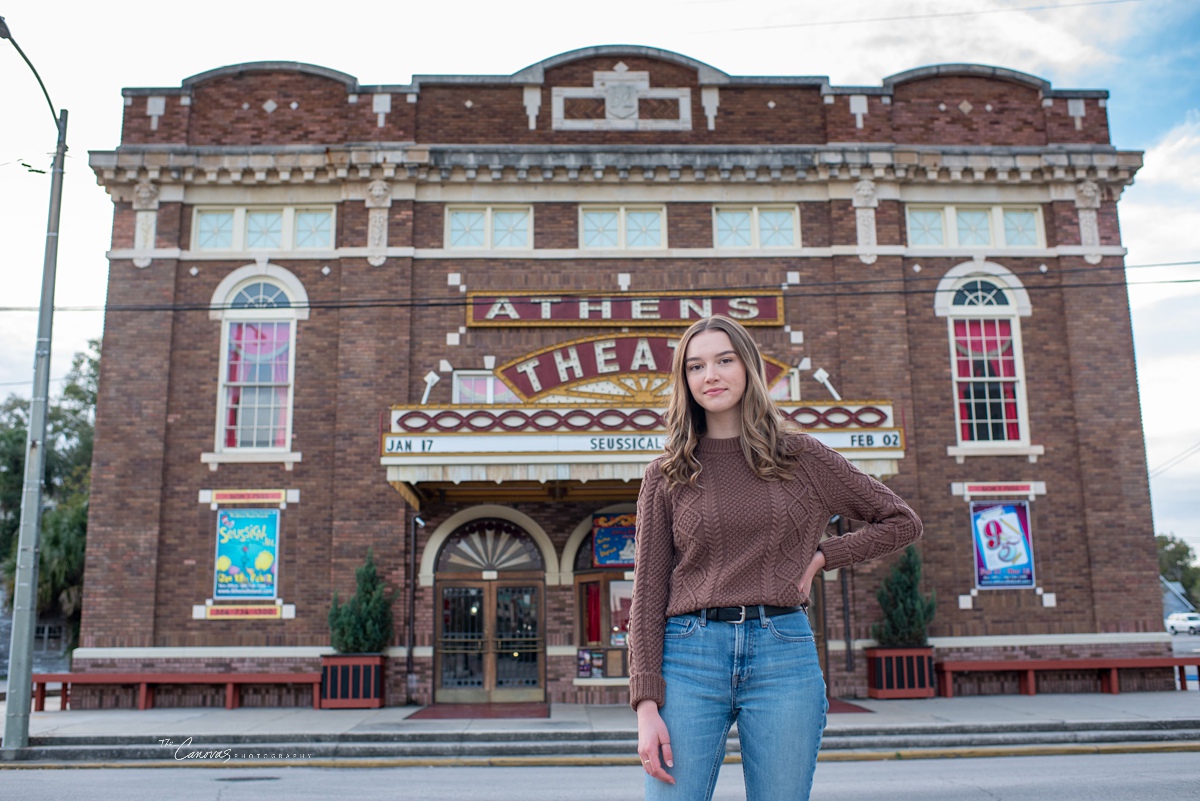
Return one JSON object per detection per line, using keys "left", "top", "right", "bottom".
{"left": 34, "top": 673, "right": 320, "bottom": 712}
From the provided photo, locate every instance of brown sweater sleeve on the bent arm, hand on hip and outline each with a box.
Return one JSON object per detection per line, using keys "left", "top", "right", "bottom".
{"left": 794, "top": 434, "right": 922, "bottom": 570}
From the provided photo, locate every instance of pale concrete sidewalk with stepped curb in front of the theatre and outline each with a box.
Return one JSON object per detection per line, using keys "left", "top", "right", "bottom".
{"left": 0, "top": 691, "right": 1200, "bottom": 767}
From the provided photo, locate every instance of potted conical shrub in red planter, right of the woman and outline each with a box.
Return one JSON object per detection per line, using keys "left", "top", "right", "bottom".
{"left": 866, "top": 546, "right": 937, "bottom": 698}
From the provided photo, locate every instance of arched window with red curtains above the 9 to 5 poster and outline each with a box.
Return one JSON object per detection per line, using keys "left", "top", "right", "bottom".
{"left": 949, "top": 278, "right": 1028, "bottom": 444}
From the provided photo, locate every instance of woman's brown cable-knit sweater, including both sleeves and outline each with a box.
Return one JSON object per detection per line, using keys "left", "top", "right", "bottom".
{"left": 629, "top": 434, "right": 922, "bottom": 709}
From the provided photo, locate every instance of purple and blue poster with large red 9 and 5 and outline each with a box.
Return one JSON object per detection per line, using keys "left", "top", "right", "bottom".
{"left": 971, "top": 500, "right": 1036, "bottom": 590}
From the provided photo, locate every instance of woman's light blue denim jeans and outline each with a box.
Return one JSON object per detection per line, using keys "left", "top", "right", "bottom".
{"left": 646, "top": 612, "right": 828, "bottom": 801}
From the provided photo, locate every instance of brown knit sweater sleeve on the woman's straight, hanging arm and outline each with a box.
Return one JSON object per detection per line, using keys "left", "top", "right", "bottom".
{"left": 629, "top": 459, "right": 674, "bottom": 709}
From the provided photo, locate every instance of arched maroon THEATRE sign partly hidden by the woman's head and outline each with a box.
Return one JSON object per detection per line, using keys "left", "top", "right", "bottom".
{"left": 496, "top": 333, "right": 788, "bottom": 401}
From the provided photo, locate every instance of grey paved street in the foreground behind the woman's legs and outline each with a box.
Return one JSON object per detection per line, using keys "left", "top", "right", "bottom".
{"left": 0, "top": 753, "right": 1200, "bottom": 801}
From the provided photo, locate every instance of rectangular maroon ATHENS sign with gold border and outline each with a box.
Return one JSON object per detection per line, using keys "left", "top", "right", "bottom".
{"left": 467, "top": 290, "right": 784, "bottom": 329}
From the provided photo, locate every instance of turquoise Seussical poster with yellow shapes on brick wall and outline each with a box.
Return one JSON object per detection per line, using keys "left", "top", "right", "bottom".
{"left": 212, "top": 508, "right": 280, "bottom": 601}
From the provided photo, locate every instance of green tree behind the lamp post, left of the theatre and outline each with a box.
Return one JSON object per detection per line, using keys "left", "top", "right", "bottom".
{"left": 0, "top": 339, "right": 100, "bottom": 648}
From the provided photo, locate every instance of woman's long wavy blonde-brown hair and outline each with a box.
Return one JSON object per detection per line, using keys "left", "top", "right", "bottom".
{"left": 660, "top": 314, "right": 796, "bottom": 488}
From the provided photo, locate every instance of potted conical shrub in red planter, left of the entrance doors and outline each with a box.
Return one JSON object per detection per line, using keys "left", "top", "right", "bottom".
{"left": 320, "top": 549, "right": 396, "bottom": 709}
